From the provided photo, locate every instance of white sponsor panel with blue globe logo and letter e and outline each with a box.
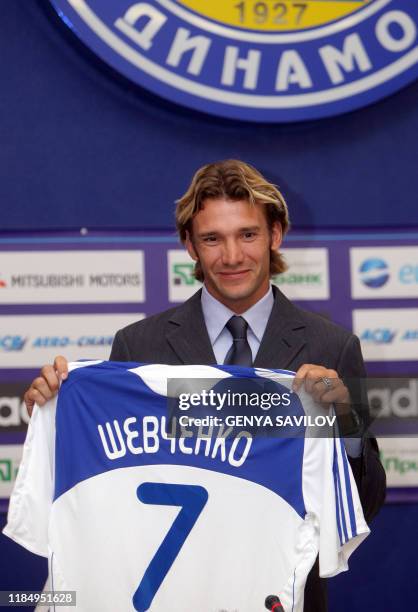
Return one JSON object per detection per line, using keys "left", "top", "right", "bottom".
{"left": 350, "top": 246, "right": 418, "bottom": 299}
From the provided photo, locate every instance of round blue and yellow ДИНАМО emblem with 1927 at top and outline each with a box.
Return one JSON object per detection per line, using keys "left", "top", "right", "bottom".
{"left": 51, "top": 0, "right": 418, "bottom": 122}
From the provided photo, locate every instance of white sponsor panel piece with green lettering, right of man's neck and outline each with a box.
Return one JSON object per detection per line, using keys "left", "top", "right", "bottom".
{"left": 272, "top": 248, "right": 330, "bottom": 300}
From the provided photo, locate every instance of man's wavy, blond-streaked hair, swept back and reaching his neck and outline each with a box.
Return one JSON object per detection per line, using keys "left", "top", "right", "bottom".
{"left": 176, "top": 159, "right": 289, "bottom": 281}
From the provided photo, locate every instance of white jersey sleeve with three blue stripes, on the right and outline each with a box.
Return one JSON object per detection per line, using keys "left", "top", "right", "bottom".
{"left": 303, "top": 430, "right": 370, "bottom": 578}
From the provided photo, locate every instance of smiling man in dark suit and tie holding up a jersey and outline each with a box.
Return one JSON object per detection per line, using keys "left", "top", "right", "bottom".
{"left": 25, "top": 160, "right": 385, "bottom": 612}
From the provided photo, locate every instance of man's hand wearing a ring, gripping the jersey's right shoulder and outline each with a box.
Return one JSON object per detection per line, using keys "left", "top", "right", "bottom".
{"left": 293, "top": 363, "right": 350, "bottom": 411}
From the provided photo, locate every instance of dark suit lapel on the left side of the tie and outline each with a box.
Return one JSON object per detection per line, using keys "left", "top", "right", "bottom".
{"left": 166, "top": 290, "right": 216, "bottom": 365}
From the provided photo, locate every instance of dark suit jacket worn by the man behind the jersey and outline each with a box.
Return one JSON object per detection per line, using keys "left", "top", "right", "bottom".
{"left": 110, "top": 287, "right": 386, "bottom": 612}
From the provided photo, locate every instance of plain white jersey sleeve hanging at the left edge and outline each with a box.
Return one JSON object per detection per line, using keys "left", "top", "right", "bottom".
{"left": 3, "top": 399, "right": 56, "bottom": 557}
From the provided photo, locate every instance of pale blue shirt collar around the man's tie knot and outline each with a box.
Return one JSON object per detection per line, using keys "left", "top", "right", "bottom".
{"left": 201, "top": 285, "right": 274, "bottom": 345}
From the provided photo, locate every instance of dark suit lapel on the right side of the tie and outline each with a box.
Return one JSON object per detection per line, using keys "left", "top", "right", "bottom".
{"left": 254, "top": 287, "right": 306, "bottom": 369}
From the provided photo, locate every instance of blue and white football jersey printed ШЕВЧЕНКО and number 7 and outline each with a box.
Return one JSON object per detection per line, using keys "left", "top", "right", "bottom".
{"left": 4, "top": 362, "right": 369, "bottom": 612}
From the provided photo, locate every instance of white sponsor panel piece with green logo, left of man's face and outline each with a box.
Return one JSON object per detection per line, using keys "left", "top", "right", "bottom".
{"left": 167, "top": 249, "right": 202, "bottom": 302}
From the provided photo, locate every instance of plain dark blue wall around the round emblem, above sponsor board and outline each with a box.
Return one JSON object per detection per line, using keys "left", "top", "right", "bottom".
{"left": 0, "top": 0, "right": 418, "bottom": 229}
